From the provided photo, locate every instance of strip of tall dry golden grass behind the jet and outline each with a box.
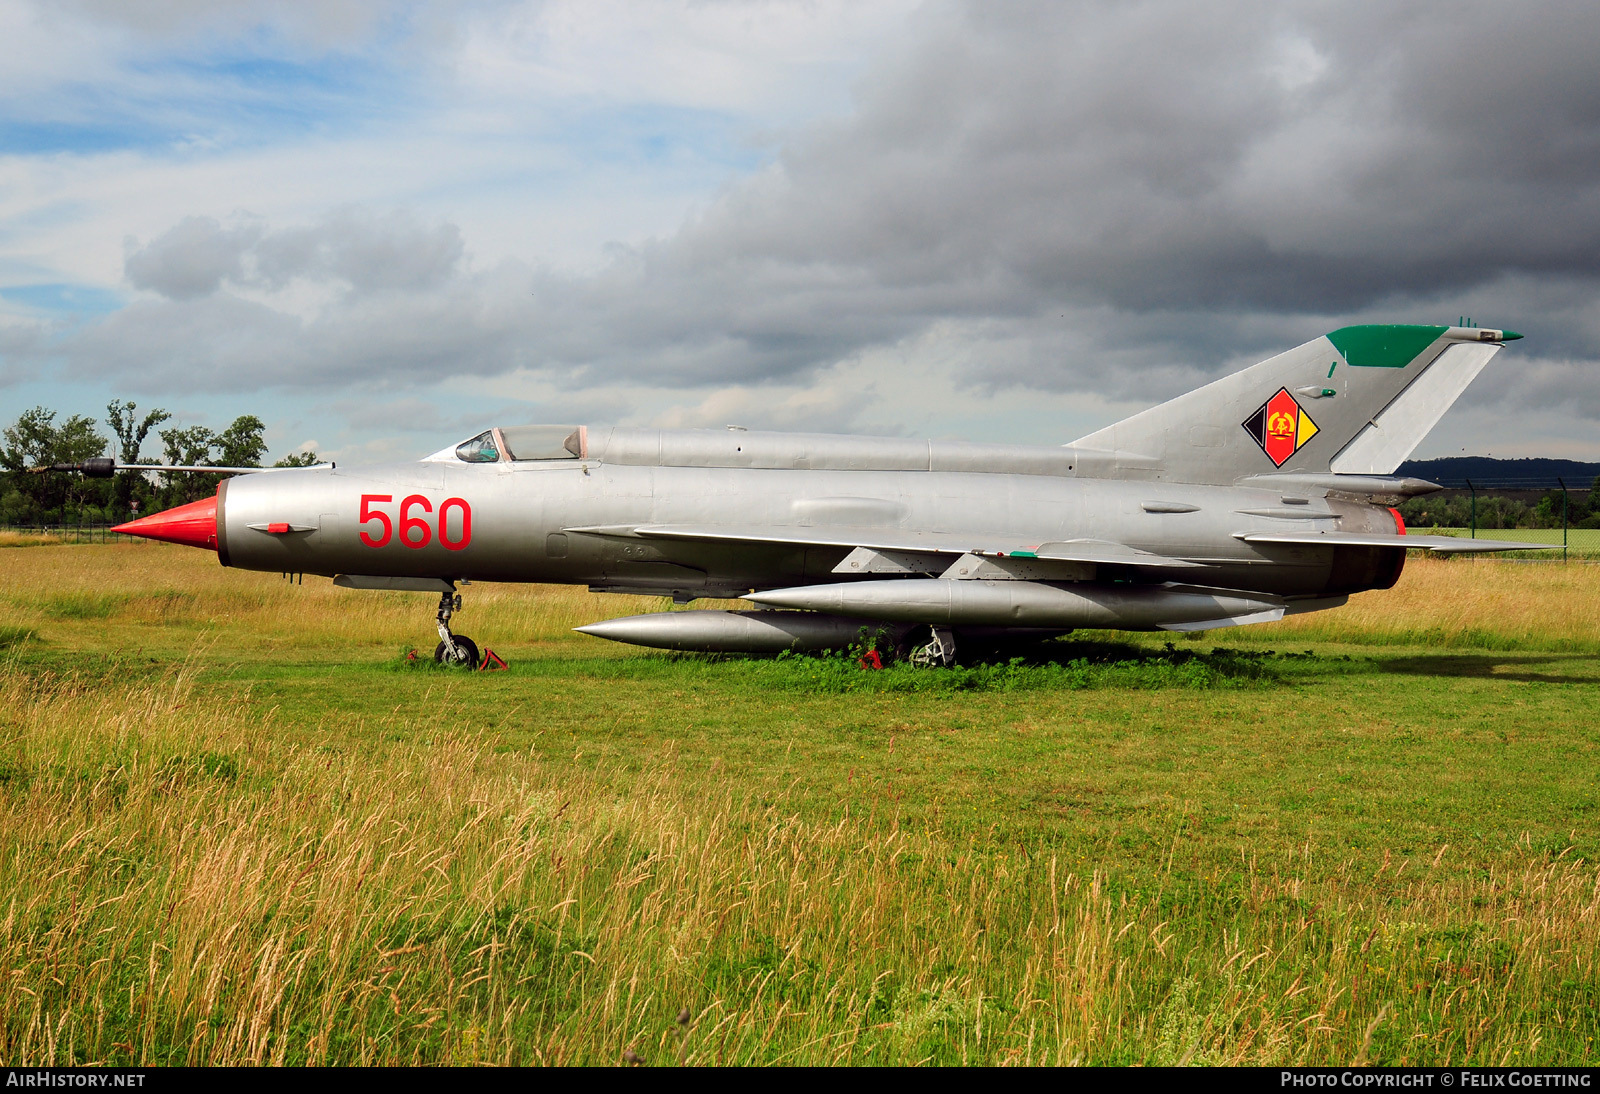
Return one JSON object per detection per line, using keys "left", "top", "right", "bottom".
{"left": 12, "top": 544, "right": 1600, "bottom": 656}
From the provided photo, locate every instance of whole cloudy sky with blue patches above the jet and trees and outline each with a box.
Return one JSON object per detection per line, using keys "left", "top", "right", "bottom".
{"left": 0, "top": 0, "right": 1600, "bottom": 459}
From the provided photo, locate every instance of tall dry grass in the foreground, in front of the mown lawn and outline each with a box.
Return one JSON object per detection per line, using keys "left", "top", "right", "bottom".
{"left": 0, "top": 649, "right": 1600, "bottom": 1065}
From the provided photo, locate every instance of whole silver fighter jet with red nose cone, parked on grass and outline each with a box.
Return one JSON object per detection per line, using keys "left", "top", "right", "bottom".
{"left": 77, "top": 325, "right": 1526, "bottom": 665}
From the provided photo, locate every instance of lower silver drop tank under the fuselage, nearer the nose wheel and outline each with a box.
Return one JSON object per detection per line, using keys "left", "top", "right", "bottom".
{"left": 574, "top": 609, "right": 904, "bottom": 653}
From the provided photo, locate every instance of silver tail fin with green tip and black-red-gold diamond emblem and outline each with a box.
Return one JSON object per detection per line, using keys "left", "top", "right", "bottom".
{"left": 1069, "top": 325, "right": 1522, "bottom": 485}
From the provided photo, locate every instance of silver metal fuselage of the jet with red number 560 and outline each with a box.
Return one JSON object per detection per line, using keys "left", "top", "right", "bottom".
{"left": 218, "top": 430, "right": 1405, "bottom": 600}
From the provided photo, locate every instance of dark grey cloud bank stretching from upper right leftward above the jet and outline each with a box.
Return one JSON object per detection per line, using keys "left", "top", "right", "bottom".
{"left": 37, "top": 0, "right": 1600, "bottom": 409}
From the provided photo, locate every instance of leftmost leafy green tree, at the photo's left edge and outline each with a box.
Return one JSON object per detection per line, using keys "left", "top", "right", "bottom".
{"left": 0, "top": 406, "right": 109, "bottom": 523}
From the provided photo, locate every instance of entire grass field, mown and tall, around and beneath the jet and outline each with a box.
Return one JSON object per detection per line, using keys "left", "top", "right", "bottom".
{"left": 0, "top": 544, "right": 1600, "bottom": 1065}
